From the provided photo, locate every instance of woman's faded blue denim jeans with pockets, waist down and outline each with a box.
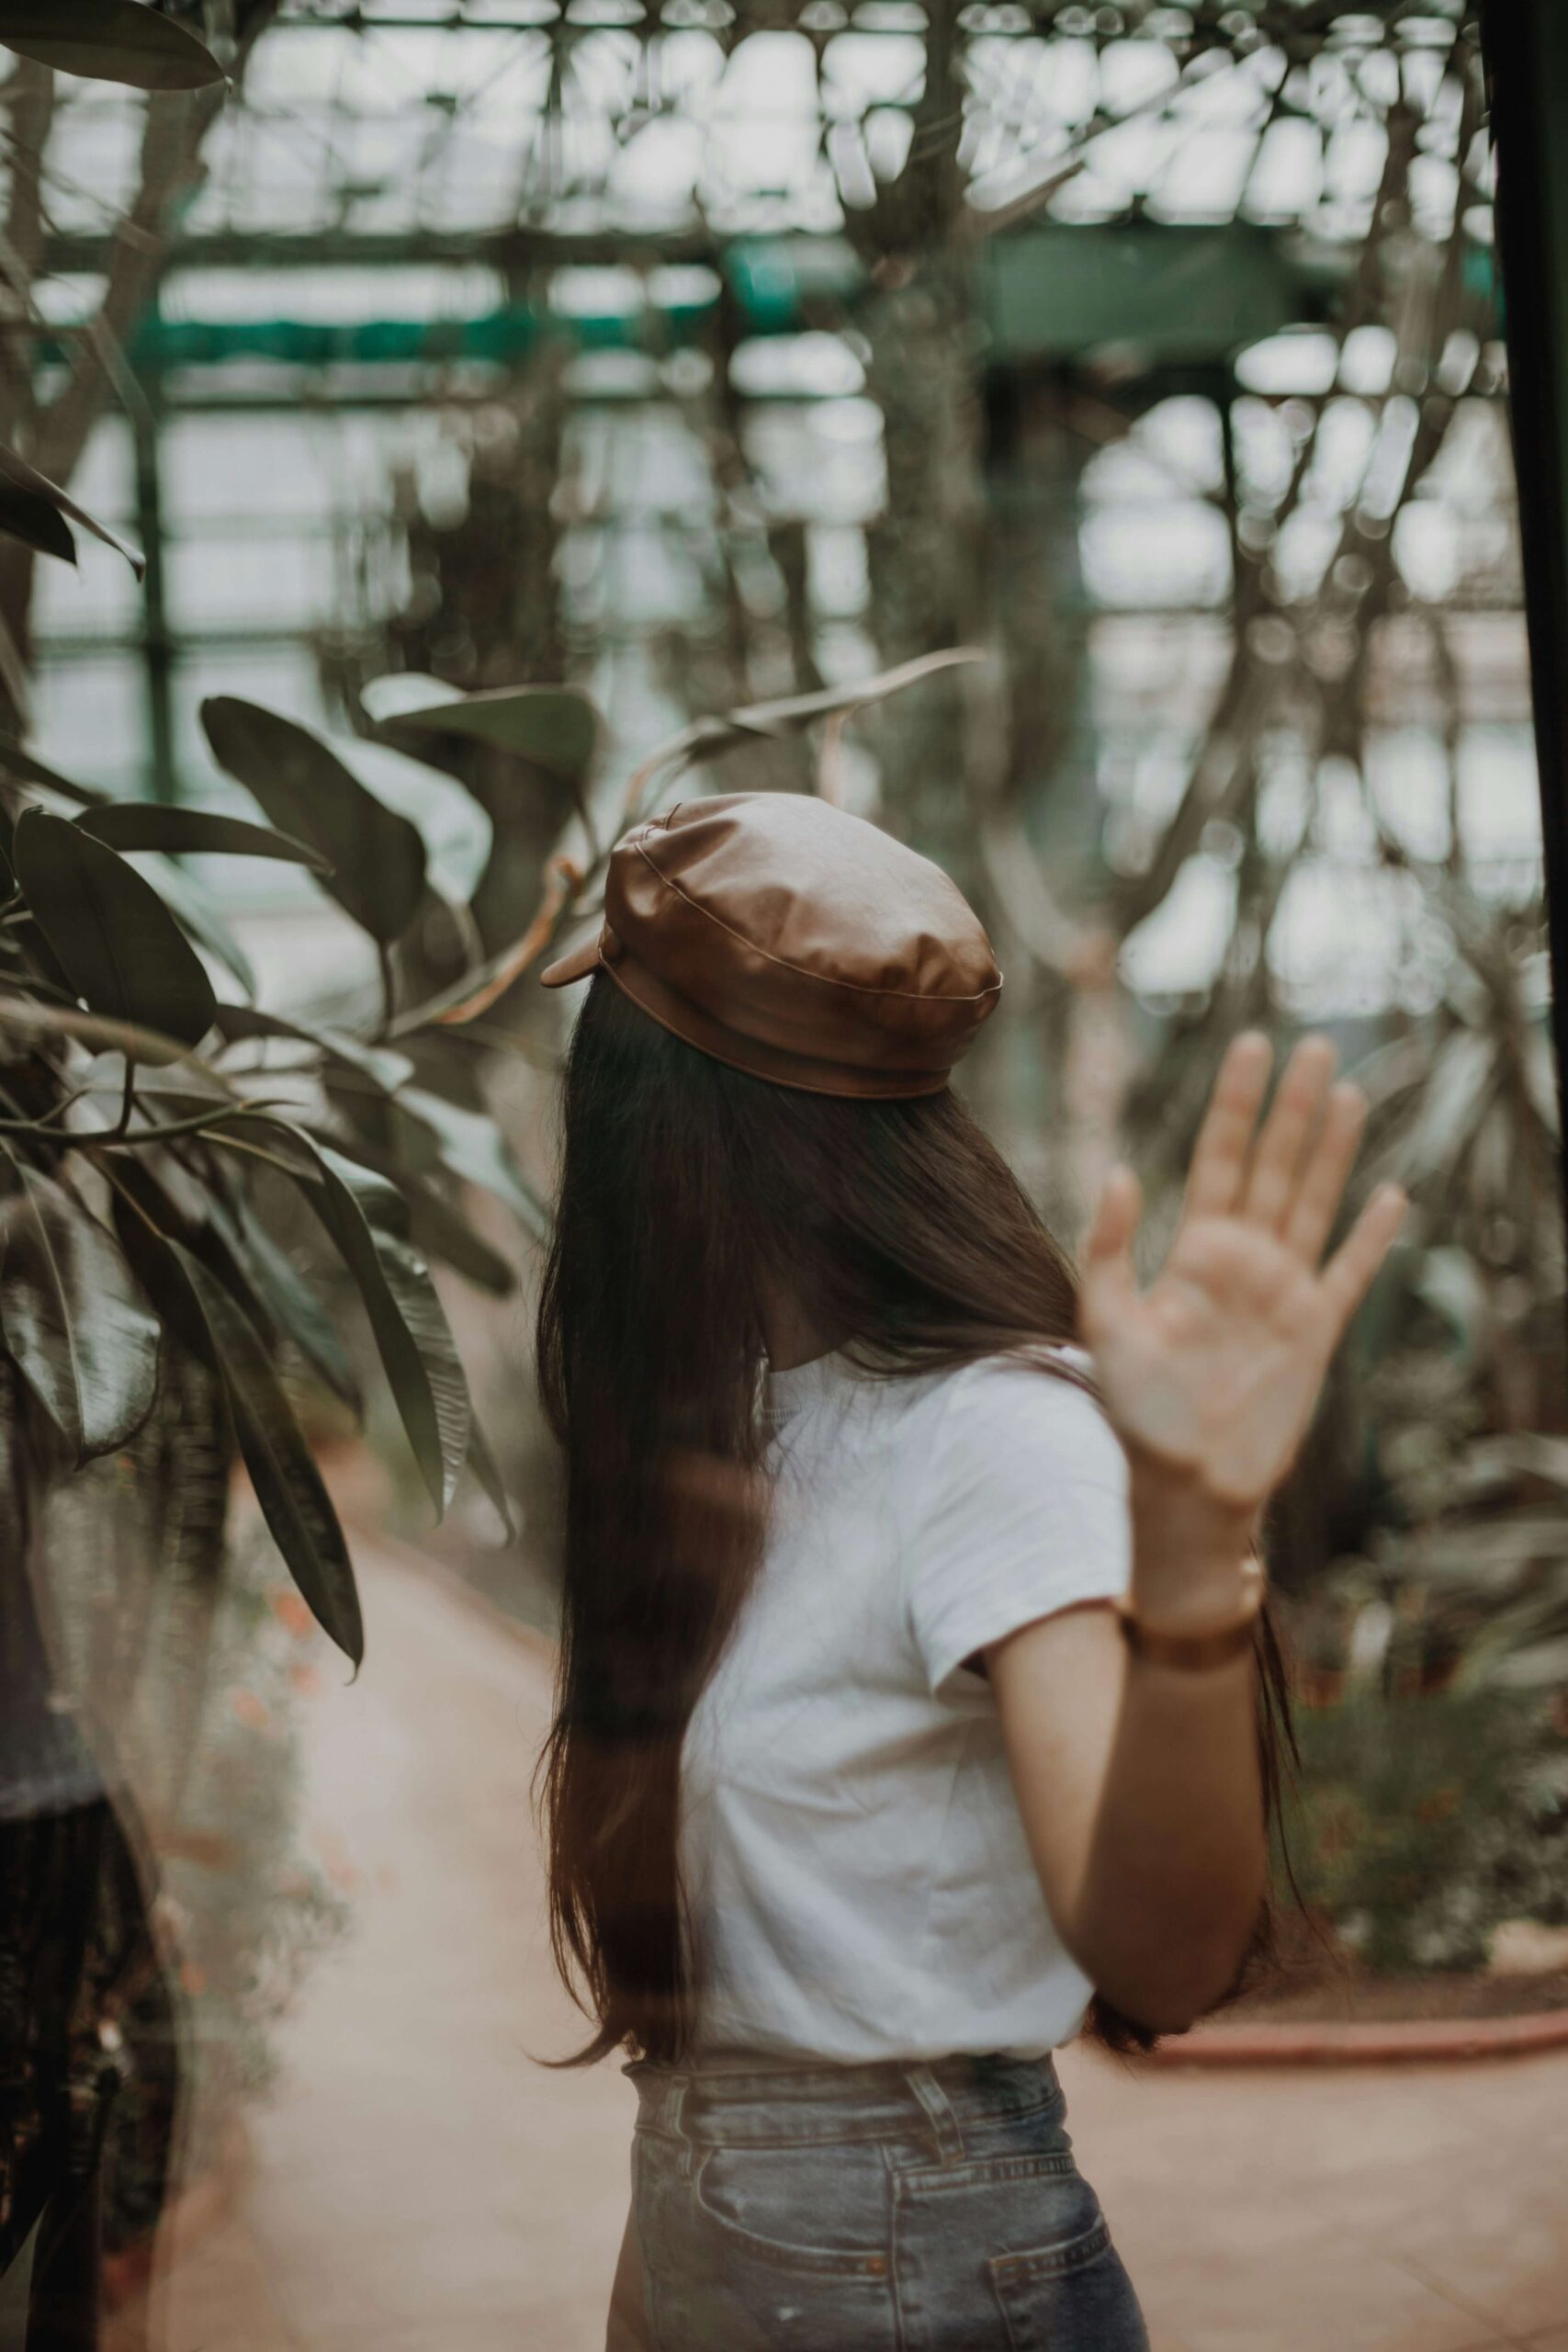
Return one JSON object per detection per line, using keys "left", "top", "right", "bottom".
{"left": 626, "top": 2058, "right": 1149, "bottom": 2352}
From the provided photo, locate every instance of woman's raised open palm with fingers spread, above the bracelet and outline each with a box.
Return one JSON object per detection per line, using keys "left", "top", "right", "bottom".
{"left": 1079, "top": 1030, "right": 1405, "bottom": 1520}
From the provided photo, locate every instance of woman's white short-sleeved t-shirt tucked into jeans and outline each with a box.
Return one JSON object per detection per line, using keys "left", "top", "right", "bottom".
{"left": 682, "top": 1350, "right": 1131, "bottom": 2063}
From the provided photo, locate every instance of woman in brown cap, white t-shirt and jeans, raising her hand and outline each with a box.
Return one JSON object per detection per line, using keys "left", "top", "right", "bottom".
{"left": 538, "top": 795, "right": 1404, "bottom": 2352}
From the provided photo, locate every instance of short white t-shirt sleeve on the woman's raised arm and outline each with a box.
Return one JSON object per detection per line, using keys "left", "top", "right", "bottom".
{"left": 903, "top": 1362, "right": 1134, "bottom": 1693}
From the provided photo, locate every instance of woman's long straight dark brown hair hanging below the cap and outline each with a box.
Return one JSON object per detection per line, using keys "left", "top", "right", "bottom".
{"left": 538, "top": 974, "right": 1295, "bottom": 2065}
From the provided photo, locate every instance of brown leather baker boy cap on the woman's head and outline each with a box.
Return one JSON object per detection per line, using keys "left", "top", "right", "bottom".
{"left": 541, "top": 793, "right": 1001, "bottom": 1096}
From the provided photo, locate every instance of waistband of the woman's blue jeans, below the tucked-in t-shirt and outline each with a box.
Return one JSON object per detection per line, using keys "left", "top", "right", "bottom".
{"left": 623, "top": 2053, "right": 1063, "bottom": 2147}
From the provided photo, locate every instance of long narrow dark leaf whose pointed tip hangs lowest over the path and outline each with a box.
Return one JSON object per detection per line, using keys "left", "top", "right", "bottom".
{"left": 118, "top": 1194, "right": 365, "bottom": 1665}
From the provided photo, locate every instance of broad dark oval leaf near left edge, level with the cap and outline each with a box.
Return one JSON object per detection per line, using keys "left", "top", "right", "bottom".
{"left": 14, "top": 809, "right": 216, "bottom": 1046}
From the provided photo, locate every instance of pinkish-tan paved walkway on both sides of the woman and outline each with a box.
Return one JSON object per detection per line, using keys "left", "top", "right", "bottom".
{"left": 143, "top": 1545, "right": 1568, "bottom": 2352}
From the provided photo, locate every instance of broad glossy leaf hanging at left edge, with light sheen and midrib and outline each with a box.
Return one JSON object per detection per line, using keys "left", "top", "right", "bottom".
{"left": 0, "top": 1162, "right": 157, "bottom": 1463}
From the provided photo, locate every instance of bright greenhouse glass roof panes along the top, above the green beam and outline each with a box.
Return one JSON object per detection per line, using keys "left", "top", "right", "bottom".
{"left": 36, "top": 0, "right": 1462, "bottom": 249}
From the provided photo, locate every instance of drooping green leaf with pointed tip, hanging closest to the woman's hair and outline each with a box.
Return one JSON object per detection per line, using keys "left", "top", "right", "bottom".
{"left": 294, "top": 1129, "right": 468, "bottom": 1520}
